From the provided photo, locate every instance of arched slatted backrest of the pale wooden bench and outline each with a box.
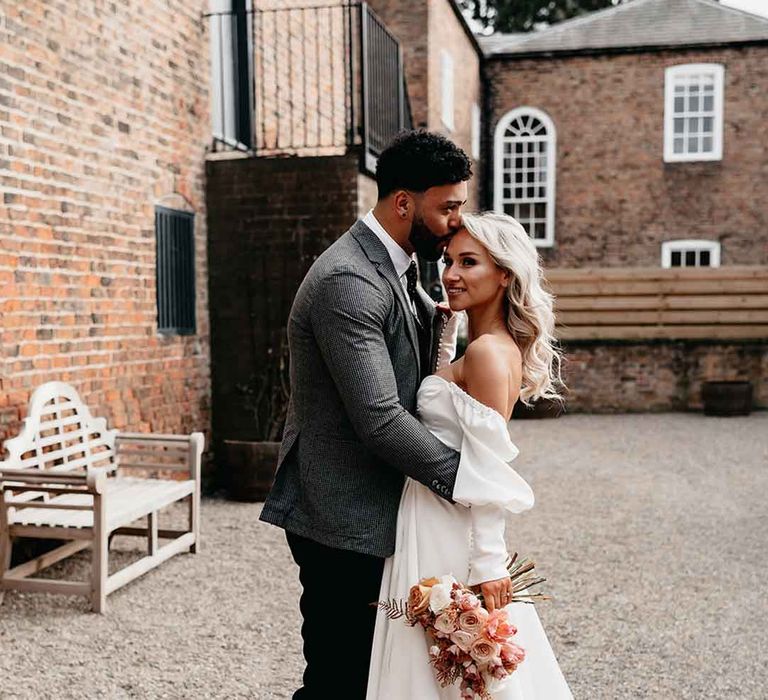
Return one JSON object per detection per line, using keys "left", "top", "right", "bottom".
{"left": 4, "top": 382, "right": 117, "bottom": 472}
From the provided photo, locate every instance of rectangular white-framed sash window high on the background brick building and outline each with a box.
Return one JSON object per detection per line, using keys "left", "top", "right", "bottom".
{"left": 664, "top": 63, "right": 725, "bottom": 163}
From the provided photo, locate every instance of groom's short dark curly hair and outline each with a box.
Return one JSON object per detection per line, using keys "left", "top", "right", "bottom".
{"left": 376, "top": 129, "right": 472, "bottom": 199}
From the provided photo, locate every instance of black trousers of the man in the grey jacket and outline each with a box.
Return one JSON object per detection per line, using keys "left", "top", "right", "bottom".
{"left": 286, "top": 532, "right": 394, "bottom": 700}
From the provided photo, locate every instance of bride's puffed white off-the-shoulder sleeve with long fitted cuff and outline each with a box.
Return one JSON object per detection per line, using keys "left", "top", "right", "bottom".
{"left": 449, "top": 384, "right": 534, "bottom": 586}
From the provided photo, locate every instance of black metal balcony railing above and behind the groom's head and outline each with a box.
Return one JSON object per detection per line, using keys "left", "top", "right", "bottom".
{"left": 205, "top": 0, "right": 412, "bottom": 172}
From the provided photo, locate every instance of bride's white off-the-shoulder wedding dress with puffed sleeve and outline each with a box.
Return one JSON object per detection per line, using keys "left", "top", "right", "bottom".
{"left": 366, "top": 375, "right": 572, "bottom": 700}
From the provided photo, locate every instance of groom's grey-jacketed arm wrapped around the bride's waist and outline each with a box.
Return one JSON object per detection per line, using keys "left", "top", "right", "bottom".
{"left": 311, "top": 269, "right": 459, "bottom": 500}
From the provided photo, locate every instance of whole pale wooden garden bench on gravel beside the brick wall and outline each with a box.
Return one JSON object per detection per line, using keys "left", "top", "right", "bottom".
{"left": 0, "top": 382, "right": 204, "bottom": 612}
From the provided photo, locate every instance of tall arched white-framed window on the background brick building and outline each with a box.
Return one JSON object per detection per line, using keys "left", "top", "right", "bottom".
{"left": 494, "top": 107, "right": 556, "bottom": 247}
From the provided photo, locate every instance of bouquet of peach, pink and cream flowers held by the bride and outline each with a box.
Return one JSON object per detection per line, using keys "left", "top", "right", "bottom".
{"left": 378, "top": 554, "right": 547, "bottom": 700}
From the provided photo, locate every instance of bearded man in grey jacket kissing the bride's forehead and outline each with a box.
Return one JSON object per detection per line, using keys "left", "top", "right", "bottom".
{"left": 261, "top": 131, "right": 472, "bottom": 700}
